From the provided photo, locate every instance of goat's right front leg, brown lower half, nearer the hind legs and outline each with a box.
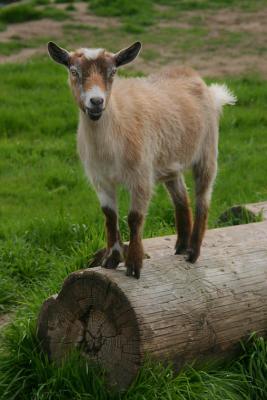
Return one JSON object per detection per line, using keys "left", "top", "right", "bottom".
{"left": 125, "top": 183, "right": 151, "bottom": 279}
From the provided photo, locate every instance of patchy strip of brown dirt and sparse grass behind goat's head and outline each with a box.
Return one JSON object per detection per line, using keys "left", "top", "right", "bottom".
{"left": 0, "top": 2, "right": 267, "bottom": 77}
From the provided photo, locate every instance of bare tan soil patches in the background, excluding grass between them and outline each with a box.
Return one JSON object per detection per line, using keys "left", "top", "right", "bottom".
{"left": 0, "top": 3, "right": 267, "bottom": 76}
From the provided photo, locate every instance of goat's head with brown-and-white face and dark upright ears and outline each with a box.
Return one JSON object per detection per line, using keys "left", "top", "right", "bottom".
{"left": 48, "top": 42, "right": 141, "bottom": 121}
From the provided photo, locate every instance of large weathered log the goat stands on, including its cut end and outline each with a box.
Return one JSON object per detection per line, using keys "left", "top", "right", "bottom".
{"left": 38, "top": 217, "right": 267, "bottom": 388}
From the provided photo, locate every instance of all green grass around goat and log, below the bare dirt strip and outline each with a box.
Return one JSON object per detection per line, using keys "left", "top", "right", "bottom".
{"left": 0, "top": 59, "right": 267, "bottom": 400}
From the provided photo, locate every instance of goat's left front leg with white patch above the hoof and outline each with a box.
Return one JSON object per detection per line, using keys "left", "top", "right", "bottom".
{"left": 93, "top": 188, "right": 123, "bottom": 269}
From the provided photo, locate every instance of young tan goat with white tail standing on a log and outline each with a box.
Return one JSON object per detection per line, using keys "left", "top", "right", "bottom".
{"left": 48, "top": 42, "right": 235, "bottom": 278}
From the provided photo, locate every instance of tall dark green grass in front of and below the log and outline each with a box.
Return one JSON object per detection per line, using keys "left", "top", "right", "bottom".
{"left": 0, "top": 312, "right": 267, "bottom": 400}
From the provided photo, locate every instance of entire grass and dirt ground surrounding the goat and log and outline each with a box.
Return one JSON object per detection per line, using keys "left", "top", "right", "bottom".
{"left": 0, "top": 0, "right": 267, "bottom": 400}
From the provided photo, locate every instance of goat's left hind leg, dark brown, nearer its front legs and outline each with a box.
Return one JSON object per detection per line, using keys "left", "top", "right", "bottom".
{"left": 165, "top": 175, "right": 192, "bottom": 254}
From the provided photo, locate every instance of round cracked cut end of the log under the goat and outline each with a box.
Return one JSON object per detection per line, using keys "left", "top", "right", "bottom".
{"left": 38, "top": 270, "right": 141, "bottom": 388}
